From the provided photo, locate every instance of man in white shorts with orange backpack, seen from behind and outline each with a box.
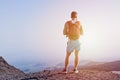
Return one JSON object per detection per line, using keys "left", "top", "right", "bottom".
{"left": 63, "top": 11, "right": 83, "bottom": 73}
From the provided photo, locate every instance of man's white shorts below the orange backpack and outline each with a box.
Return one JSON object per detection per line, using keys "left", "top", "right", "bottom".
{"left": 66, "top": 39, "right": 80, "bottom": 52}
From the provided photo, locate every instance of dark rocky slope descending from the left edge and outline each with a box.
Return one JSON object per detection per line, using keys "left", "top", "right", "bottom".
{"left": 0, "top": 56, "right": 24, "bottom": 80}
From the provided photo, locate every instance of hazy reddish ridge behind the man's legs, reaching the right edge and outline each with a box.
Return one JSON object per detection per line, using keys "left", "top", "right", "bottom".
{"left": 56, "top": 60, "right": 120, "bottom": 71}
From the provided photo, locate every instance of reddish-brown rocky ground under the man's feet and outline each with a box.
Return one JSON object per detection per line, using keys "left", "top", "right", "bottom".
{"left": 22, "top": 70, "right": 120, "bottom": 80}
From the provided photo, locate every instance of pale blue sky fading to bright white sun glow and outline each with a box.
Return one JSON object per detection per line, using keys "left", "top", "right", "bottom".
{"left": 0, "top": 0, "right": 120, "bottom": 65}
